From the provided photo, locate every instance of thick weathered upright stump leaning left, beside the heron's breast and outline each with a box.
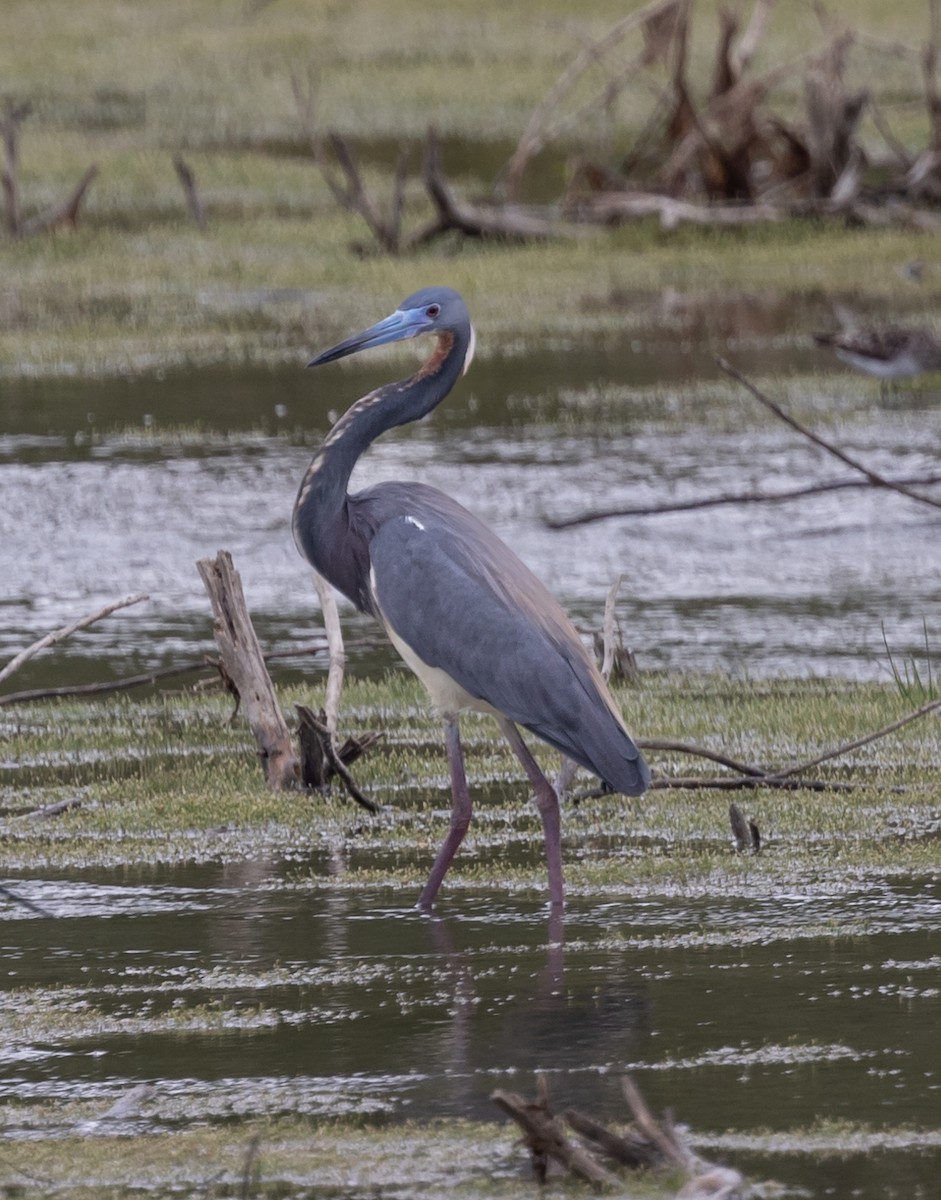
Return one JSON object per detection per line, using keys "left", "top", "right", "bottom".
{"left": 196, "top": 550, "right": 298, "bottom": 790}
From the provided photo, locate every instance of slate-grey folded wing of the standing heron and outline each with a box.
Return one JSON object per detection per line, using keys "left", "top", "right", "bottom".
{"left": 370, "top": 510, "right": 646, "bottom": 792}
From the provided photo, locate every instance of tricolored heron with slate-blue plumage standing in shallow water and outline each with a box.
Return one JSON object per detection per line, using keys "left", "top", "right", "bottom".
{"left": 294, "top": 288, "right": 651, "bottom": 910}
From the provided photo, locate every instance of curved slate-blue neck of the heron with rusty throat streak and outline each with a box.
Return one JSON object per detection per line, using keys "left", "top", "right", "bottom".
{"left": 294, "top": 334, "right": 469, "bottom": 607}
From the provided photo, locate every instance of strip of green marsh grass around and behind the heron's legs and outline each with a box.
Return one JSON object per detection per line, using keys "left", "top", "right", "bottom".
{"left": 0, "top": 672, "right": 941, "bottom": 896}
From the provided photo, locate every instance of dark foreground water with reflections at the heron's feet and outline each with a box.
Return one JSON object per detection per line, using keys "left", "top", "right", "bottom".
{"left": 0, "top": 856, "right": 941, "bottom": 1196}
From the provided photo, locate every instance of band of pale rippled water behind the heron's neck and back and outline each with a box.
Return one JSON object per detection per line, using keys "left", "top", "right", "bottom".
{"left": 0, "top": 316, "right": 941, "bottom": 688}
